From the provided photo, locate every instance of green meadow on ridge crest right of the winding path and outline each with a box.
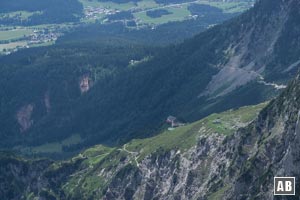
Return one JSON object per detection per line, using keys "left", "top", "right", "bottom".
{"left": 124, "top": 103, "right": 267, "bottom": 159}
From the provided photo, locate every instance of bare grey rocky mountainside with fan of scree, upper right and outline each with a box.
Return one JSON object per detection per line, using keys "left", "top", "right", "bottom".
{"left": 202, "top": 0, "right": 300, "bottom": 97}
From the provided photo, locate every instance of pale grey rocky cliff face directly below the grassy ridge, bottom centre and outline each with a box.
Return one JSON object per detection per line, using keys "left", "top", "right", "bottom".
{"left": 104, "top": 134, "right": 230, "bottom": 200}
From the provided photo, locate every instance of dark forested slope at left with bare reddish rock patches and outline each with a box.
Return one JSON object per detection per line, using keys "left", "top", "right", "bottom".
{"left": 0, "top": 40, "right": 153, "bottom": 150}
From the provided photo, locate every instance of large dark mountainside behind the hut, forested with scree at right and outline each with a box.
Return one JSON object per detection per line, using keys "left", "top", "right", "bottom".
{"left": 63, "top": 1, "right": 299, "bottom": 145}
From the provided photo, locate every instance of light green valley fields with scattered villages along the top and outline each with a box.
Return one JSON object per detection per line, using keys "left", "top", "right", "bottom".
{"left": 0, "top": 0, "right": 252, "bottom": 54}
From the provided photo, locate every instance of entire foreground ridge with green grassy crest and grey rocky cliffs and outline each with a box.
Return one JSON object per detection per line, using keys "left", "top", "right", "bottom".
{"left": 0, "top": 68, "right": 300, "bottom": 200}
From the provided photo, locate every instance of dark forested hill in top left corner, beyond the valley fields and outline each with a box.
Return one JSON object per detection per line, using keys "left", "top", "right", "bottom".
{"left": 0, "top": 0, "right": 83, "bottom": 26}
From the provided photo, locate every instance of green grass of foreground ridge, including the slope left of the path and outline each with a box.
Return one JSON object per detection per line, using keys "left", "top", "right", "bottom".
{"left": 63, "top": 103, "right": 267, "bottom": 198}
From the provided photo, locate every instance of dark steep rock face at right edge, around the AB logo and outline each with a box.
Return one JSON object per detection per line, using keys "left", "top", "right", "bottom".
{"left": 226, "top": 75, "right": 300, "bottom": 199}
